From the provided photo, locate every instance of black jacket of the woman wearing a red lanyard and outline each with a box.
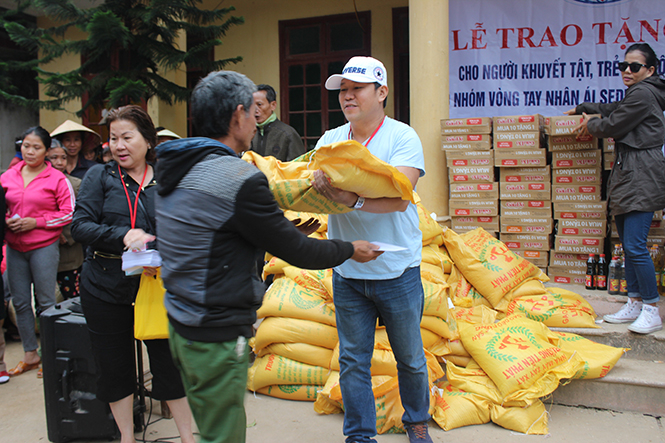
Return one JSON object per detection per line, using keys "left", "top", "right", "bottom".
{"left": 72, "top": 161, "right": 157, "bottom": 304}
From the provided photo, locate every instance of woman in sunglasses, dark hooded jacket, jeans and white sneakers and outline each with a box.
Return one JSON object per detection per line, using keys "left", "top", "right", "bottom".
{"left": 566, "top": 43, "right": 665, "bottom": 334}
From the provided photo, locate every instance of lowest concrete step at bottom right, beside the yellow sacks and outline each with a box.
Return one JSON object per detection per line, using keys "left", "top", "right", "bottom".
{"left": 552, "top": 358, "right": 665, "bottom": 417}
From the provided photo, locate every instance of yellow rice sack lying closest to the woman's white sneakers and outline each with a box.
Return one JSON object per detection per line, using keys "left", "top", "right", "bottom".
{"left": 497, "top": 288, "right": 599, "bottom": 328}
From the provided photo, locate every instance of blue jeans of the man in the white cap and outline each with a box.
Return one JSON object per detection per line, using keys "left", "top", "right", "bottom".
{"left": 333, "top": 266, "right": 430, "bottom": 442}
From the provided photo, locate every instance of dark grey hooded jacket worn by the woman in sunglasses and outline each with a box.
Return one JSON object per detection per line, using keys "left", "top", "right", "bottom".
{"left": 576, "top": 75, "right": 665, "bottom": 215}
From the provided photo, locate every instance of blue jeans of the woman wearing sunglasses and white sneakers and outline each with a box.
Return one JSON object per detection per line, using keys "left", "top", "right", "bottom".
{"left": 615, "top": 211, "right": 660, "bottom": 303}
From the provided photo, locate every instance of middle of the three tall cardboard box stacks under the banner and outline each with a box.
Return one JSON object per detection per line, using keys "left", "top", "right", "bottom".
{"left": 493, "top": 114, "right": 552, "bottom": 269}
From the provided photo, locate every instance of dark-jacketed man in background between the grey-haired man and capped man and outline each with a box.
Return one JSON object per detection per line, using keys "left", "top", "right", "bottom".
{"left": 250, "top": 85, "right": 305, "bottom": 162}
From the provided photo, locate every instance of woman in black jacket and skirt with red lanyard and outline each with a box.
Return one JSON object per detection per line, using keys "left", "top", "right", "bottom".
{"left": 72, "top": 106, "right": 194, "bottom": 443}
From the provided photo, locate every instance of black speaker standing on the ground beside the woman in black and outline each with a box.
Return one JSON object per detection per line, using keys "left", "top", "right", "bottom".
{"left": 40, "top": 297, "right": 120, "bottom": 443}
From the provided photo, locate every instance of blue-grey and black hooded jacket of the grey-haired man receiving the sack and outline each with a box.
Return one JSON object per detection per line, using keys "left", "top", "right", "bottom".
{"left": 156, "top": 138, "right": 354, "bottom": 342}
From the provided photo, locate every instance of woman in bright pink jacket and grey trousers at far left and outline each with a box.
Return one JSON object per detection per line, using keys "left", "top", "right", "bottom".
{"left": 0, "top": 126, "right": 74, "bottom": 376}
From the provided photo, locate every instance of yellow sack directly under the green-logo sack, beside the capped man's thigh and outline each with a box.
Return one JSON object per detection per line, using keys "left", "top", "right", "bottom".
{"left": 255, "top": 317, "right": 339, "bottom": 351}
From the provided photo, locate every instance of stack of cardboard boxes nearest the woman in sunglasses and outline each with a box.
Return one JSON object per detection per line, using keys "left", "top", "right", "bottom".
{"left": 545, "top": 116, "right": 607, "bottom": 284}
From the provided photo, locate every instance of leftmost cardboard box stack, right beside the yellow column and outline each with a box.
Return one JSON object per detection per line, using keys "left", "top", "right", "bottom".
{"left": 441, "top": 117, "right": 499, "bottom": 233}
